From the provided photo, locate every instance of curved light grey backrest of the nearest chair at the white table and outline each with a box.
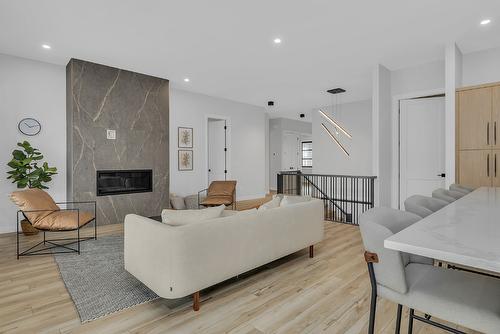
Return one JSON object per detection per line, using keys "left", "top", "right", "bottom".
{"left": 359, "top": 208, "right": 421, "bottom": 293}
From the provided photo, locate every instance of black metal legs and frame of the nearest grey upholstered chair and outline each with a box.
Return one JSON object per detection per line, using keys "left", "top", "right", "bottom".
{"left": 365, "top": 252, "right": 466, "bottom": 334}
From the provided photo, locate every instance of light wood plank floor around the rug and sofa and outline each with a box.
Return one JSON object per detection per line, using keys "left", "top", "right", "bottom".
{"left": 0, "top": 198, "right": 476, "bottom": 334}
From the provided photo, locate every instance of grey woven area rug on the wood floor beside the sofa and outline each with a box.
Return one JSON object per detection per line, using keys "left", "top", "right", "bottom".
{"left": 54, "top": 235, "right": 189, "bottom": 322}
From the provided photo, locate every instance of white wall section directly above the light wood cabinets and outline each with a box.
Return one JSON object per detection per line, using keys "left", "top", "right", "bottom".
{"left": 462, "top": 48, "right": 500, "bottom": 86}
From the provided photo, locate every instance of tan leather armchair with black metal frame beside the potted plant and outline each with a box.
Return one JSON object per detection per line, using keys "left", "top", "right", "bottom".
{"left": 10, "top": 189, "right": 97, "bottom": 259}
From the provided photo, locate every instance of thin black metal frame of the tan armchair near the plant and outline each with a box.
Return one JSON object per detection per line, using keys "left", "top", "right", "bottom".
{"left": 16, "top": 201, "right": 97, "bottom": 260}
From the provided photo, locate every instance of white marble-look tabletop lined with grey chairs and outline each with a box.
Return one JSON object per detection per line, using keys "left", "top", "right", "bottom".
{"left": 384, "top": 187, "right": 500, "bottom": 273}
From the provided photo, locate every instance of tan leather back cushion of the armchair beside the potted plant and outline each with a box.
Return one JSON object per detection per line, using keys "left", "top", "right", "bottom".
{"left": 10, "top": 189, "right": 60, "bottom": 224}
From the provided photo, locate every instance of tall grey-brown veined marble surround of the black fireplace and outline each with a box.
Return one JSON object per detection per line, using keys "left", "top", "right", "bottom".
{"left": 66, "top": 59, "right": 169, "bottom": 225}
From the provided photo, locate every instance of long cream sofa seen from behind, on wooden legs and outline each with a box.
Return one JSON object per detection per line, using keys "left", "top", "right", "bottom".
{"left": 124, "top": 199, "right": 324, "bottom": 310}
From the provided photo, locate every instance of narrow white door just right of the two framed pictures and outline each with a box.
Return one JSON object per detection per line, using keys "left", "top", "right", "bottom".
{"left": 208, "top": 119, "right": 226, "bottom": 184}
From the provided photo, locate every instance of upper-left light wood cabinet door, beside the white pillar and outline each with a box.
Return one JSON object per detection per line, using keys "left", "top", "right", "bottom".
{"left": 458, "top": 87, "right": 493, "bottom": 150}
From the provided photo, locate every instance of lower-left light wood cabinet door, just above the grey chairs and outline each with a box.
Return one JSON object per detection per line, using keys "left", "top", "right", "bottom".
{"left": 459, "top": 150, "right": 492, "bottom": 188}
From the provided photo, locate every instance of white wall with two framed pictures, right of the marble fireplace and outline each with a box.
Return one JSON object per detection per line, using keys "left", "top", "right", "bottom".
{"left": 170, "top": 89, "right": 269, "bottom": 200}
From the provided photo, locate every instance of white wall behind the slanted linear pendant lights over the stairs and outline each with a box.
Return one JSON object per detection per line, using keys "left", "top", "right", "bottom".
{"left": 312, "top": 100, "right": 372, "bottom": 175}
